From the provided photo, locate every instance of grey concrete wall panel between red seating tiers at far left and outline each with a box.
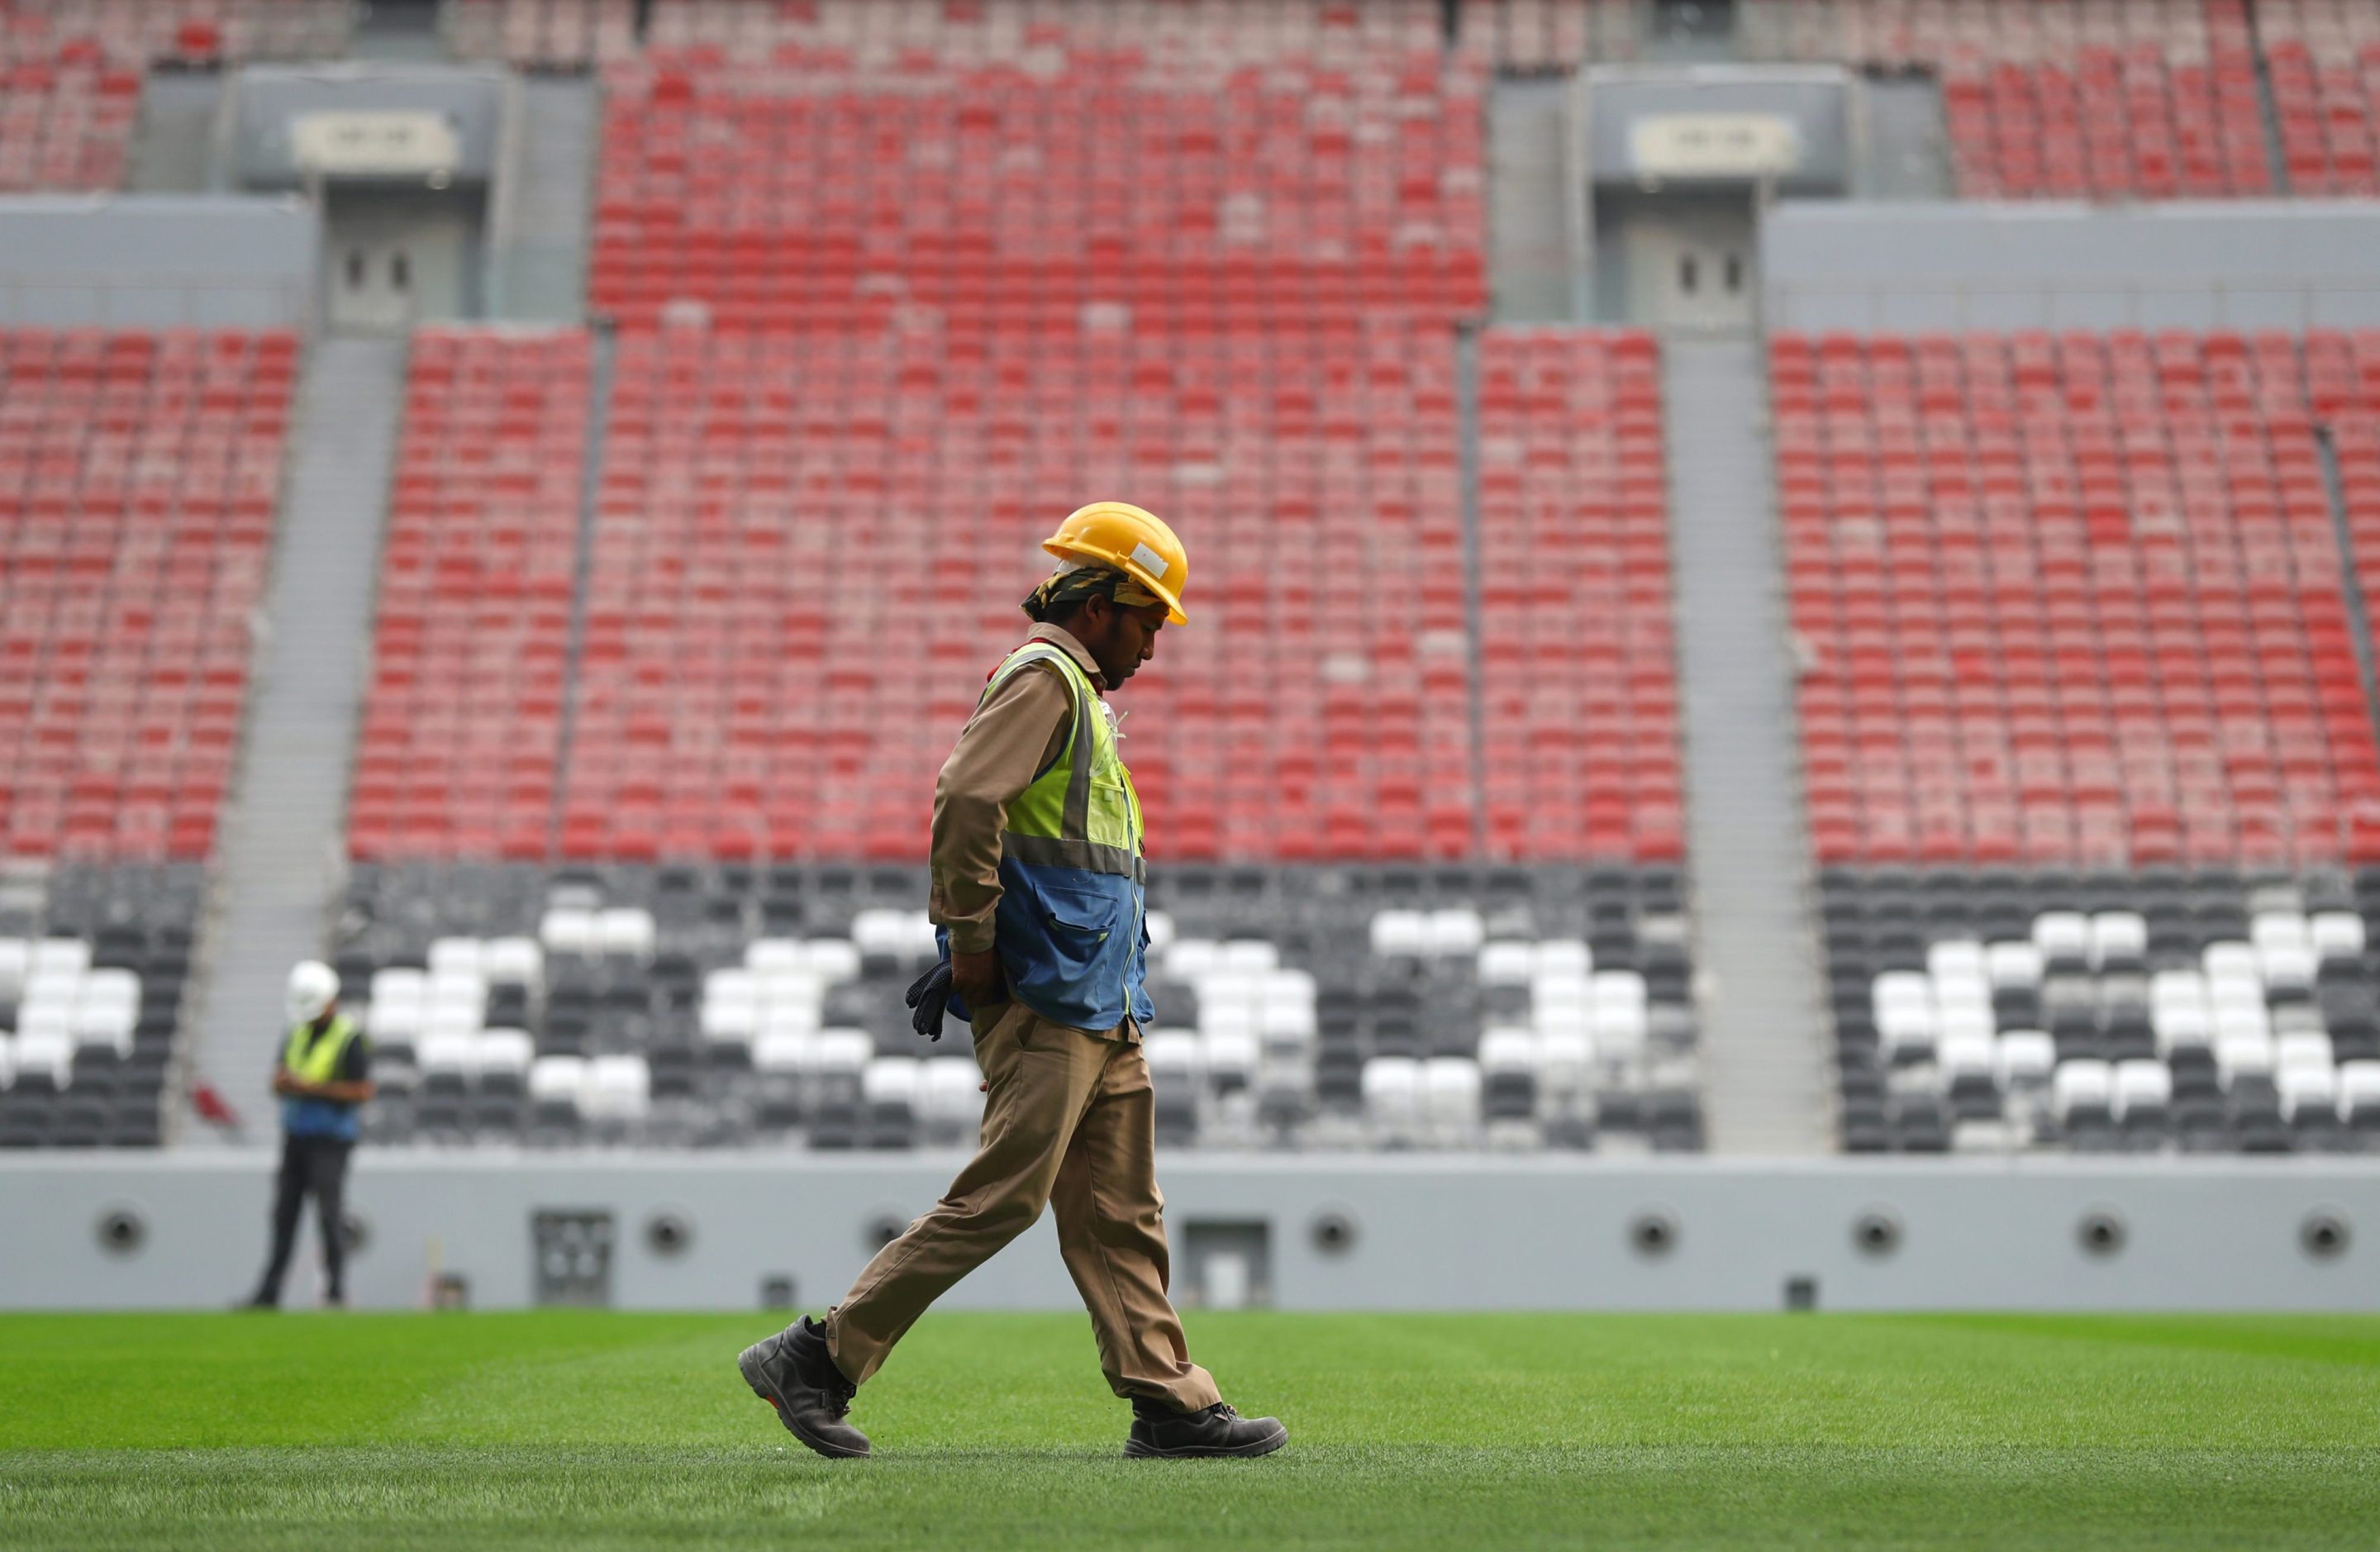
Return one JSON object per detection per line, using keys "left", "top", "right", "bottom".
{"left": 0, "top": 195, "right": 321, "bottom": 328}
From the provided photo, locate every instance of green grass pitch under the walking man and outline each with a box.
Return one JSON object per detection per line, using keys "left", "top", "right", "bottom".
{"left": 0, "top": 1312, "right": 2380, "bottom": 1552}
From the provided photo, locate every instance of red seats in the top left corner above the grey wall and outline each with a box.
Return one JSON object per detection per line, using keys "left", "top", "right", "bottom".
{"left": 0, "top": 0, "right": 352, "bottom": 193}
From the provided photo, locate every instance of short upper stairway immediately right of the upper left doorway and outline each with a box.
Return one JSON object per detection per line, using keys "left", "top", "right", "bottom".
{"left": 490, "top": 76, "right": 602, "bottom": 324}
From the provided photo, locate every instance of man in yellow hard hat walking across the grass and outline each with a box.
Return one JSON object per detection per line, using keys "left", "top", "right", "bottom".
{"left": 738, "top": 502, "right": 1288, "bottom": 1457}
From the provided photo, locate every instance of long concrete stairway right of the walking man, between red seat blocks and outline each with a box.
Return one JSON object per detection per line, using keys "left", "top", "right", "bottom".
{"left": 1664, "top": 336, "right": 1833, "bottom": 1154}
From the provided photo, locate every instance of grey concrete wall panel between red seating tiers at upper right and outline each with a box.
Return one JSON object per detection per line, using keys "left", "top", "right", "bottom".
{"left": 1761, "top": 200, "right": 2380, "bottom": 331}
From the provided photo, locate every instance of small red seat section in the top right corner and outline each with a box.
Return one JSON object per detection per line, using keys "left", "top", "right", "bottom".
{"left": 2256, "top": 0, "right": 2380, "bottom": 198}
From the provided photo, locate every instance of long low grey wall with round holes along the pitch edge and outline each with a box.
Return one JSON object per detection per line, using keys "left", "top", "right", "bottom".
{"left": 0, "top": 1152, "right": 2380, "bottom": 1309}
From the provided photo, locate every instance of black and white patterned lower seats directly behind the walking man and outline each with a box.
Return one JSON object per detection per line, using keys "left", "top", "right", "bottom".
{"left": 338, "top": 864, "right": 1702, "bottom": 1150}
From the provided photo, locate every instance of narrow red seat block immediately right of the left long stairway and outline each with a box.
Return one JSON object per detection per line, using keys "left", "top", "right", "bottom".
{"left": 347, "top": 328, "right": 590, "bottom": 857}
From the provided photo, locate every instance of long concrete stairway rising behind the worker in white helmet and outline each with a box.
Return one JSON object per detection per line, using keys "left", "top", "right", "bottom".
{"left": 193, "top": 338, "right": 405, "bottom": 1121}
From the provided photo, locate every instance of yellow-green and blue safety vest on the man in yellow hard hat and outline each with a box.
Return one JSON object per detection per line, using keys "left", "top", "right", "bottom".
{"left": 942, "top": 640, "right": 1157, "bottom": 1033}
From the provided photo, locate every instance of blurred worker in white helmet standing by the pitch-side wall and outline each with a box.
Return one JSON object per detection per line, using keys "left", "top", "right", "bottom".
{"left": 248, "top": 959, "right": 371, "bottom": 1309}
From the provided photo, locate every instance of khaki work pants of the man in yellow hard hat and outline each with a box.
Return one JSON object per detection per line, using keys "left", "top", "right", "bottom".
{"left": 826, "top": 1000, "right": 1223, "bottom": 1412}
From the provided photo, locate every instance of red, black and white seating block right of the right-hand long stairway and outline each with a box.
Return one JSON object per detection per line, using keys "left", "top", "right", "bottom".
{"left": 1773, "top": 333, "right": 2380, "bottom": 1152}
